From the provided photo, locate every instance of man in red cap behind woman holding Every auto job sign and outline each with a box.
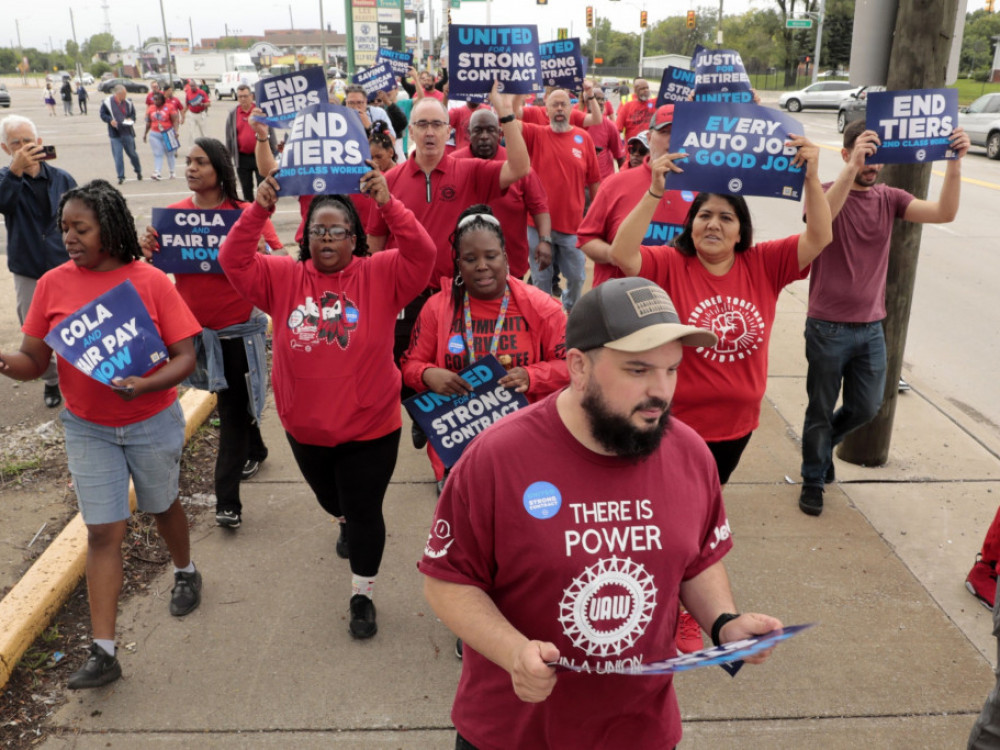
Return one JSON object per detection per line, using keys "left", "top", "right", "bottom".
{"left": 576, "top": 104, "right": 695, "bottom": 286}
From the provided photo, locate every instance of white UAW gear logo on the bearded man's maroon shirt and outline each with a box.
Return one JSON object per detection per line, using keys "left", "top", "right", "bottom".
{"left": 559, "top": 557, "right": 656, "bottom": 656}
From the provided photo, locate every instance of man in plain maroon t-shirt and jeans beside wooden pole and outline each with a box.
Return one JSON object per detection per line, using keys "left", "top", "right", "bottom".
{"left": 799, "top": 120, "right": 969, "bottom": 516}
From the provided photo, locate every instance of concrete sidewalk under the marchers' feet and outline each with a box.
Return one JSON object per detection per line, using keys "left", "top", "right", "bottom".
{"left": 25, "top": 283, "right": 1000, "bottom": 750}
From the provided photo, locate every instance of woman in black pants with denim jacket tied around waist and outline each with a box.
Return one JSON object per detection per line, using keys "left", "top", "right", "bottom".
{"left": 140, "top": 138, "right": 282, "bottom": 529}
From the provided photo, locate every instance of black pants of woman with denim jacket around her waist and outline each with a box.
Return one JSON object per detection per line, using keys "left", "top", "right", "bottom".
{"left": 215, "top": 339, "right": 267, "bottom": 513}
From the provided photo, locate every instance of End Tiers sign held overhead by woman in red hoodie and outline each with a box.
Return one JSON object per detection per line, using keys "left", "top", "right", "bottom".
{"left": 277, "top": 102, "right": 371, "bottom": 195}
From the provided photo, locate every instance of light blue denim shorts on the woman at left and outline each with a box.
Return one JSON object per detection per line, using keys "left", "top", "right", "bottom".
{"left": 59, "top": 401, "right": 184, "bottom": 525}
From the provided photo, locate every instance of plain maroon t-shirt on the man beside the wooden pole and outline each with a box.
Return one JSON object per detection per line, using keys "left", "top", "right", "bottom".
{"left": 809, "top": 183, "right": 913, "bottom": 323}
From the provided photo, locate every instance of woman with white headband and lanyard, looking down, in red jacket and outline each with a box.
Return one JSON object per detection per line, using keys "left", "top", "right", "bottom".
{"left": 400, "top": 204, "right": 569, "bottom": 493}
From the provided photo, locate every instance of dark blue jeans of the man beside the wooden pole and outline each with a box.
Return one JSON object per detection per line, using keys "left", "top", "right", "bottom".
{"left": 802, "top": 318, "right": 886, "bottom": 487}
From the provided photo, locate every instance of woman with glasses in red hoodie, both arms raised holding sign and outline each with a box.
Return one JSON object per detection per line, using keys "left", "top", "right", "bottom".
{"left": 219, "top": 162, "right": 437, "bottom": 638}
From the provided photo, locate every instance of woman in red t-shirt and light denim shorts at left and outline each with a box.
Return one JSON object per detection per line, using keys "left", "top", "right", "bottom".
{"left": 0, "top": 180, "right": 201, "bottom": 689}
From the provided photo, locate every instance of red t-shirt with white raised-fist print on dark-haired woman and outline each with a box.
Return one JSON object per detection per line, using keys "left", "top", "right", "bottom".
{"left": 639, "top": 235, "right": 809, "bottom": 442}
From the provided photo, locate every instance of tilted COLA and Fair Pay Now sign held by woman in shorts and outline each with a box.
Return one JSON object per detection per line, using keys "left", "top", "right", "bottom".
{"left": 45, "top": 279, "right": 167, "bottom": 385}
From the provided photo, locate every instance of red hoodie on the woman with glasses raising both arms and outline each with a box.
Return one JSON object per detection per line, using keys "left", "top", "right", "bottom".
{"left": 219, "top": 198, "right": 437, "bottom": 446}
